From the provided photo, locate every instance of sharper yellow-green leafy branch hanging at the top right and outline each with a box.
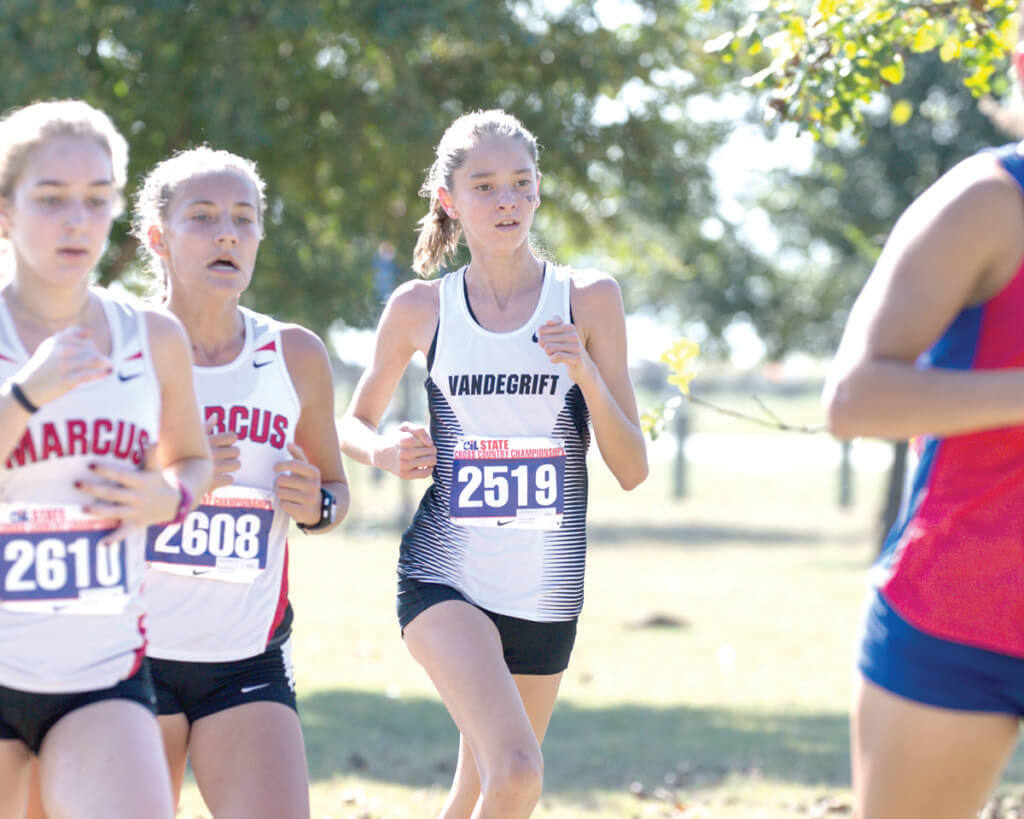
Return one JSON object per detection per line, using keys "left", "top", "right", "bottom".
{"left": 709, "top": 0, "right": 1017, "bottom": 141}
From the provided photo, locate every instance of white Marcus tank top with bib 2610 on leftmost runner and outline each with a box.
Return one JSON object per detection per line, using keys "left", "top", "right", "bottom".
{"left": 0, "top": 290, "right": 160, "bottom": 693}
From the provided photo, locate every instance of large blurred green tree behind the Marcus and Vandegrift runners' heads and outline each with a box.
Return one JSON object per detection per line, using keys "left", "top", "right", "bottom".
{"left": 0, "top": 0, "right": 757, "bottom": 341}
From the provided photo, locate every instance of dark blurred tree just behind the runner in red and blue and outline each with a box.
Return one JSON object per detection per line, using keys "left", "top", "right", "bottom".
{"left": 755, "top": 54, "right": 1010, "bottom": 537}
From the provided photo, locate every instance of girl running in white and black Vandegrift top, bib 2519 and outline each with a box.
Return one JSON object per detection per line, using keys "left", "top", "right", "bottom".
{"left": 342, "top": 111, "right": 647, "bottom": 819}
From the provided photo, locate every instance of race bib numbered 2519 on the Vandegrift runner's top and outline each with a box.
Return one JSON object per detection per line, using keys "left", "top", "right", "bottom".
{"left": 449, "top": 436, "right": 565, "bottom": 529}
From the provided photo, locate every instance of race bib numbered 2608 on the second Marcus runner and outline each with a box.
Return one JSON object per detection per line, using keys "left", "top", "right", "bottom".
{"left": 145, "top": 486, "right": 273, "bottom": 583}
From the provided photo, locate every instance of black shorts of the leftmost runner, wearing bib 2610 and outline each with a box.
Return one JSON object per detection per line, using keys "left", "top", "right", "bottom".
{"left": 0, "top": 659, "right": 157, "bottom": 753}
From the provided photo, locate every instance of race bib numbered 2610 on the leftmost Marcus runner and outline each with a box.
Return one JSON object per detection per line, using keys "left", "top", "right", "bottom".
{"left": 0, "top": 504, "right": 131, "bottom": 614}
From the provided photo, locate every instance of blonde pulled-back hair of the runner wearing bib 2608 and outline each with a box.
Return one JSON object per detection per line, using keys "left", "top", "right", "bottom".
{"left": 131, "top": 145, "right": 266, "bottom": 295}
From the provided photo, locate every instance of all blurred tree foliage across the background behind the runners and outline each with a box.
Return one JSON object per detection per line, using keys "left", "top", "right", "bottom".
{"left": 0, "top": 0, "right": 1009, "bottom": 358}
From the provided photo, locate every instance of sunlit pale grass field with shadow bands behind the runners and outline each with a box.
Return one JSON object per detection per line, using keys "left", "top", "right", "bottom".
{"left": 174, "top": 427, "right": 1024, "bottom": 819}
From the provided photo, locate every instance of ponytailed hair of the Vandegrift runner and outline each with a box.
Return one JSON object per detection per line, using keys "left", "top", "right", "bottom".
{"left": 413, "top": 109, "right": 539, "bottom": 278}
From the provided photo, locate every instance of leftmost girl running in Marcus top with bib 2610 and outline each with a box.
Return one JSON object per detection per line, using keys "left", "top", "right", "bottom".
{"left": 0, "top": 100, "right": 211, "bottom": 819}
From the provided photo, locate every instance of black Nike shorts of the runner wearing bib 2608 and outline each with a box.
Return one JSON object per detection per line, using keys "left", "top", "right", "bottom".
{"left": 150, "top": 640, "right": 298, "bottom": 723}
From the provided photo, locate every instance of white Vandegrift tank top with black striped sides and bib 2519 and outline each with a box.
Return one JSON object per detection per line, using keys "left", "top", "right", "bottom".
{"left": 398, "top": 264, "right": 590, "bottom": 621}
